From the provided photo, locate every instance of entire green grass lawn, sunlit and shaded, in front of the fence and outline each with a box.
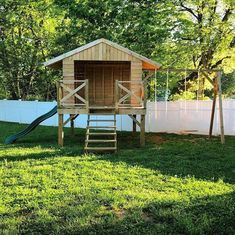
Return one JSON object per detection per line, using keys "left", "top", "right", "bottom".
{"left": 0, "top": 122, "right": 235, "bottom": 235}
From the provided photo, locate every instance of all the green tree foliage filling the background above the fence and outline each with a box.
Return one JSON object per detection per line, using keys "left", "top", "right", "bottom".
{"left": 0, "top": 0, "right": 235, "bottom": 99}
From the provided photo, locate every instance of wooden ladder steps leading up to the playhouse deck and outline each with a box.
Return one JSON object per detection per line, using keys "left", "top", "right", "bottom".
{"left": 84, "top": 114, "right": 117, "bottom": 153}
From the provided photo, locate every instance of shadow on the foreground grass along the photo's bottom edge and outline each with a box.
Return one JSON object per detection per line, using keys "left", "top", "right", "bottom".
{"left": 13, "top": 192, "right": 235, "bottom": 235}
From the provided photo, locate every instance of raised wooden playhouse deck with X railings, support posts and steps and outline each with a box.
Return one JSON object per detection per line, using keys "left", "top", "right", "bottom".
{"left": 57, "top": 79, "right": 146, "bottom": 149}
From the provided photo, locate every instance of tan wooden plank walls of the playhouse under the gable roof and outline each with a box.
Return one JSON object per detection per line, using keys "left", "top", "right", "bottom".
{"left": 63, "top": 43, "right": 143, "bottom": 106}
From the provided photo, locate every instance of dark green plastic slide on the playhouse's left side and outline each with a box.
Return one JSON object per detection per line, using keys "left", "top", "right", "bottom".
{"left": 5, "top": 106, "right": 57, "bottom": 144}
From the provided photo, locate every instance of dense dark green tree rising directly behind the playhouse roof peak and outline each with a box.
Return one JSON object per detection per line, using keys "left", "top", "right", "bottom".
{"left": 55, "top": 0, "right": 170, "bottom": 57}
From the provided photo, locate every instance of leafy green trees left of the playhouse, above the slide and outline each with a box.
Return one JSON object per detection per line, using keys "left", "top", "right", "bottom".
{"left": 0, "top": 0, "right": 61, "bottom": 99}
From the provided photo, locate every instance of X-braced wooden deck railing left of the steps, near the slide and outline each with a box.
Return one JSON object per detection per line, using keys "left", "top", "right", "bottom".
{"left": 57, "top": 79, "right": 89, "bottom": 109}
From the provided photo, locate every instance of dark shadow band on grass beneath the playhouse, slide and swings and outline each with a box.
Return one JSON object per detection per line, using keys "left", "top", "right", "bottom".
{"left": 1, "top": 124, "right": 235, "bottom": 184}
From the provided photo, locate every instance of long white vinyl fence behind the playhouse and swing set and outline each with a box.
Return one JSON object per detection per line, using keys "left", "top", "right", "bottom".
{"left": 0, "top": 99, "right": 235, "bottom": 135}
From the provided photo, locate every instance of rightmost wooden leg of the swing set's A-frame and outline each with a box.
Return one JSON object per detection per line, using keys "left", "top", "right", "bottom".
{"left": 216, "top": 72, "right": 225, "bottom": 144}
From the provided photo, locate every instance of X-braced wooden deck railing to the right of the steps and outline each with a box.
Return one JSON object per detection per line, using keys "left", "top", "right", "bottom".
{"left": 115, "top": 80, "right": 146, "bottom": 109}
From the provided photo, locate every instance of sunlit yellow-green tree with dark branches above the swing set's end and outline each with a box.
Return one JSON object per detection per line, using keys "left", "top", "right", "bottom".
{"left": 169, "top": 0, "right": 235, "bottom": 96}
